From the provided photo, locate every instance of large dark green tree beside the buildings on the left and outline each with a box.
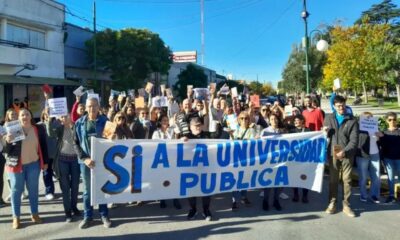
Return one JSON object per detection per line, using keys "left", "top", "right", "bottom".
{"left": 86, "top": 28, "right": 172, "bottom": 89}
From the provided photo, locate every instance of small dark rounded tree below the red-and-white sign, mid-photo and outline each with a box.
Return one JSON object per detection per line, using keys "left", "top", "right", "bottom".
{"left": 174, "top": 64, "right": 208, "bottom": 99}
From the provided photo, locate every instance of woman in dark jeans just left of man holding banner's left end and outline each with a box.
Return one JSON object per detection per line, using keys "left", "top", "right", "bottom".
{"left": 51, "top": 115, "right": 81, "bottom": 223}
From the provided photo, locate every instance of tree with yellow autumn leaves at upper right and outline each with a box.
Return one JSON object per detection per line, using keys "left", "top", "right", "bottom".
{"left": 323, "top": 18, "right": 389, "bottom": 102}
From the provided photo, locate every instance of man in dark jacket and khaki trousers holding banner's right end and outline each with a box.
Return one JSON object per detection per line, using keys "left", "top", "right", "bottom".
{"left": 324, "top": 96, "right": 359, "bottom": 217}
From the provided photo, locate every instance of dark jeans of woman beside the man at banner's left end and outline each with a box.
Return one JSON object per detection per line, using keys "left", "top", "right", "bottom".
{"left": 58, "top": 160, "right": 80, "bottom": 214}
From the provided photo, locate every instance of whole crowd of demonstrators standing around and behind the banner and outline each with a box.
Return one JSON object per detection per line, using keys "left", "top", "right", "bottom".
{"left": 0, "top": 83, "right": 400, "bottom": 229}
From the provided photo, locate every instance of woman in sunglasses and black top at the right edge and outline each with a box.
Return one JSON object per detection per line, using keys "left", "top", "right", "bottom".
{"left": 379, "top": 112, "right": 400, "bottom": 203}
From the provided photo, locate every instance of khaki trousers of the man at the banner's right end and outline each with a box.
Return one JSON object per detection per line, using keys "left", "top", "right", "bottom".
{"left": 329, "top": 158, "right": 353, "bottom": 206}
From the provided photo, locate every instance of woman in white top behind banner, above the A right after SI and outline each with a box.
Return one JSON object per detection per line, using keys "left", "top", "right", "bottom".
{"left": 152, "top": 115, "right": 182, "bottom": 209}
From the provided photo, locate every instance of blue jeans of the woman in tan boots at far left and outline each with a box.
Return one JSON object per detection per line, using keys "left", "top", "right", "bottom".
{"left": 8, "top": 160, "right": 40, "bottom": 217}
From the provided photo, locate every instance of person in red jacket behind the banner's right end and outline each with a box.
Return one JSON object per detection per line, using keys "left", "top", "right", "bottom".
{"left": 302, "top": 96, "right": 324, "bottom": 131}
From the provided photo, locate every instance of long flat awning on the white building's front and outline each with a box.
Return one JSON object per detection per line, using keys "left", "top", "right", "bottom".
{"left": 0, "top": 75, "right": 80, "bottom": 86}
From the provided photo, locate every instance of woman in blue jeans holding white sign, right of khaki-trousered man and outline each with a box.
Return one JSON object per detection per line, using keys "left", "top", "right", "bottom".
{"left": 356, "top": 112, "right": 381, "bottom": 203}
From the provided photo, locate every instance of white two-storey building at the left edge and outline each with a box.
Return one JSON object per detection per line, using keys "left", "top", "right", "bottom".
{"left": 0, "top": 0, "right": 76, "bottom": 117}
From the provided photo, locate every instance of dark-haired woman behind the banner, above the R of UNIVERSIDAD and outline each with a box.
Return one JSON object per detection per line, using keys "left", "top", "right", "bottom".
{"left": 260, "top": 113, "right": 286, "bottom": 211}
